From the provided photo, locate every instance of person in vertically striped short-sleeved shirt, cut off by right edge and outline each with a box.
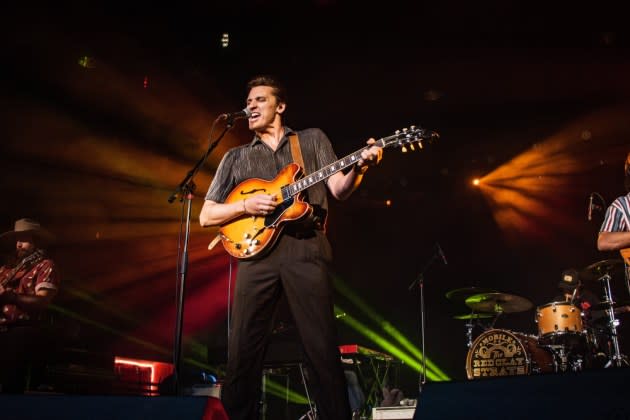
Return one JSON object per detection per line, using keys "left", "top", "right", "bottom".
{"left": 597, "top": 153, "right": 630, "bottom": 254}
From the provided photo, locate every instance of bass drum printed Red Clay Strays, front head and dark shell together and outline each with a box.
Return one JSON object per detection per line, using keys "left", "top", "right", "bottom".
{"left": 466, "top": 329, "right": 557, "bottom": 379}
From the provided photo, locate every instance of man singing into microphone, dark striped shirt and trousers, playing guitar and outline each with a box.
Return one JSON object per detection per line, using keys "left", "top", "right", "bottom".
{"left": 199, "top": 76, "right": 382, "bottom": 420}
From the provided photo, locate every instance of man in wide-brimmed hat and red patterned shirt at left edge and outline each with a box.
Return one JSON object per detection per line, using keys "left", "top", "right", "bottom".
{"left": 0, "top": 219, "right": 61, "bottom": 393}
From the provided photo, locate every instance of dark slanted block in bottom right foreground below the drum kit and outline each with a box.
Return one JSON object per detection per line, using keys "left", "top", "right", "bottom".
{"left": 413, "top": 368, "right": 630, "bottom": 420}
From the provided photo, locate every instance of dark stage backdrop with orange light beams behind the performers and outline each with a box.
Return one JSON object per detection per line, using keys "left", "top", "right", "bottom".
{"left": 0, "top": 0, "right": 630, "bottom": 395}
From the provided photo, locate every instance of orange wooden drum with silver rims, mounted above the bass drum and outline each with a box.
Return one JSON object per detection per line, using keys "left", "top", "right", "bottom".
{"left": 536, "top": 302, "right": 584, "bottom": 338}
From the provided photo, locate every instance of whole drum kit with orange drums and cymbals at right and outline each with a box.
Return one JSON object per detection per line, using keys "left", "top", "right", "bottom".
{"left": 446, "top": 260, "right": 630, "bottom": 379}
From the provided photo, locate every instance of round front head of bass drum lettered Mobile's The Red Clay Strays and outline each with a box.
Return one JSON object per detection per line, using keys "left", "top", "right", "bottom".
{"left": 466, "top": 329, "right": 530, "bottom": 379}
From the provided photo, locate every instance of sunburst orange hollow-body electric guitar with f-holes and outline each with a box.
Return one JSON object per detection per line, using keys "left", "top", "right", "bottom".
{"left": 219, "top": 126, "right": 439, "bottom": 259}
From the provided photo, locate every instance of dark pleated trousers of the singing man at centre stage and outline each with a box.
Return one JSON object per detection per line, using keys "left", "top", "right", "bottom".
{"left": 222, "top": 232, "right": 351, "bottom": 420}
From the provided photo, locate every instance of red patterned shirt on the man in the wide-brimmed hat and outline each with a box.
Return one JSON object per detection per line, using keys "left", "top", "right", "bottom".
{"left": 0, "top": 256, "right": 61, "bottom": 326}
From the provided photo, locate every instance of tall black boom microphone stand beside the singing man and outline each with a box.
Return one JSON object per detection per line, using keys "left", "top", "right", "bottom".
{"left": 168, "top": 117, "right": 234, "bottom": 395}
